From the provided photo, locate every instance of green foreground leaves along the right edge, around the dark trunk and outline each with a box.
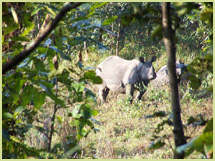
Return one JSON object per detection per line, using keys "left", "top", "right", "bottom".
{"left": 145, "top": 3, "right": 213, "bottom": 158}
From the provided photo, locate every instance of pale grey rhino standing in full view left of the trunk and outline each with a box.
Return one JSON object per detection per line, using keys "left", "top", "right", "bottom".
{"left": 96, "top": 56, "right": 156, "bottom": 103}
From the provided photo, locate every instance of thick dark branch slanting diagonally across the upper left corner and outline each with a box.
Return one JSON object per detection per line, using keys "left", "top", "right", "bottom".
{"left": 2, "top": 2, "right": 83, "bottom": 74}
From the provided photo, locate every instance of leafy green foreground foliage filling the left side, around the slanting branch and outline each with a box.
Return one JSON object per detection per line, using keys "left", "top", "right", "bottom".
{"left": 2, "top": 3, "right": 107, "bottom": 158}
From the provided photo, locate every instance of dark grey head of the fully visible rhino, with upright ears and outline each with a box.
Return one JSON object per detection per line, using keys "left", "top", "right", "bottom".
{"left": 138, "top": 56, "right": 156, "bottom": 81}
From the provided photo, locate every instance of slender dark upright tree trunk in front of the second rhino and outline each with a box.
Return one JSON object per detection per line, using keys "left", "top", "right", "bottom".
{"left": 162, "top": 2, "right": 186, "bottom": 159}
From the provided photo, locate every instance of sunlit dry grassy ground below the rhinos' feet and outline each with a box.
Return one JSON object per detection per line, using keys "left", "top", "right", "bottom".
{"left": 81, "top": 82, "right": 213, "bottom": 159}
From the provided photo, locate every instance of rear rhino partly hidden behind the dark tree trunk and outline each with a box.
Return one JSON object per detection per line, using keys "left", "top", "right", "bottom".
{"left": 151, "top": 61, "right": 187, "bottom": 88}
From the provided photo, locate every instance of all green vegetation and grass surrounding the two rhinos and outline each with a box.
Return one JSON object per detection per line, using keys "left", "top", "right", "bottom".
{"left": 2, "top": 2, "right": 213, "bottom": 159}
